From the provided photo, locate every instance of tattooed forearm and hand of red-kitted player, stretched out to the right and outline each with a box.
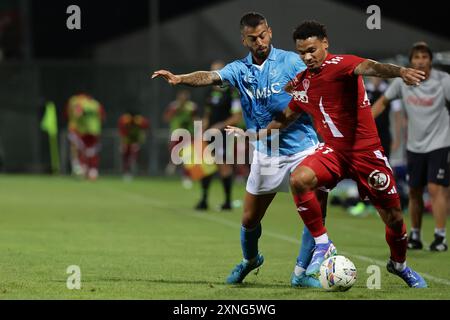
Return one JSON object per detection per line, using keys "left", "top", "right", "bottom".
{"left": 353, "top": 59, "right": 425, "bottom": 85}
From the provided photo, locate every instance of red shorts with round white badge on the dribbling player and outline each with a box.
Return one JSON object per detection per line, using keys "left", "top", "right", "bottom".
{"left": 300, "top": 144, "right": 400, "bottom": 209}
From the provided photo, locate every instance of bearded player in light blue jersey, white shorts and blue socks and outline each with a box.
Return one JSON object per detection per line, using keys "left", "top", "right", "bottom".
{"left": 152, "top": 12, "right": 327, "bottom": 287}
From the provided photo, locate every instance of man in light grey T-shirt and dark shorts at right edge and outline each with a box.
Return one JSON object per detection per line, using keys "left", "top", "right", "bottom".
{"left": 372, "top": 42, "right": 450, "bottom": 251}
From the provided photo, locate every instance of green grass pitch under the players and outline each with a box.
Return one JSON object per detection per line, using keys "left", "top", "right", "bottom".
{"left": 0, "top": 175, "right": 450, "bottom": 300}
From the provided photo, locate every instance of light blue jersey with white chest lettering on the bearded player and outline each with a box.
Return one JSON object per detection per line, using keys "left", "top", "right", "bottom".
{"left": 218, "top": 47, "right": 318, "bottom": 155}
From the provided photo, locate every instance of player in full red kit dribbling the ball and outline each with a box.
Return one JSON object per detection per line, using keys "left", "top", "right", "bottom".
{"left": 267, "top": 21, "right": 427, "bottom": 288}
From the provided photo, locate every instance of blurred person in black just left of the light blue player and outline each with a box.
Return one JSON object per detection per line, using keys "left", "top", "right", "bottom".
{"left": 195, "top": 61, "right": 245, "bottom": 210}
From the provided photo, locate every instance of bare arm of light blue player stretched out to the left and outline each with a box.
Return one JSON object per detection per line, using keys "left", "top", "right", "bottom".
{"left": 152, "top": 70, "right": 222, "bottom": 87}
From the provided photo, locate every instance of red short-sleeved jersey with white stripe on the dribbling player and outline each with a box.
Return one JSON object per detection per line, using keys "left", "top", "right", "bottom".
{"left": 289, "top": 54, "right": 380, "bottom": 151}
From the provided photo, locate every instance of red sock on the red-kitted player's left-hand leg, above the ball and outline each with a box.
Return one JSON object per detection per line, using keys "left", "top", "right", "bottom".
{"left": 294, "top": 191, "right": 327, "bottom": 237}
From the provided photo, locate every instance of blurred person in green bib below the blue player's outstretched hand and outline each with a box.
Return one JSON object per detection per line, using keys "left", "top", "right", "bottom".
{"left": 163, "top": 89, "right": 198, "bottom": 189}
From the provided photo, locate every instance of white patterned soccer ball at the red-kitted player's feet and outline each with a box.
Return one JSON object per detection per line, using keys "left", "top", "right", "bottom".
{"left": 319, "top": 256, "right": 356, "bottom": 291}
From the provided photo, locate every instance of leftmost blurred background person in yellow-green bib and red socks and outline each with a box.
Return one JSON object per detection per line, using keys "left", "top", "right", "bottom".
{"left": 66, "top": 93, "right": 105, "bottom": 180}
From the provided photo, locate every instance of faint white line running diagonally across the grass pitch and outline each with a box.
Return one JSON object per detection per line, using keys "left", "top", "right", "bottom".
{"left": 115, "top": 191, "right": 450, "bottom": 286}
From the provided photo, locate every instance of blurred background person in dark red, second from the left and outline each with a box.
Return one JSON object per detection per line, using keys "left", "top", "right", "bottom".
{"left": 118, "top": 112, "right": 150, "bottom": 180}
